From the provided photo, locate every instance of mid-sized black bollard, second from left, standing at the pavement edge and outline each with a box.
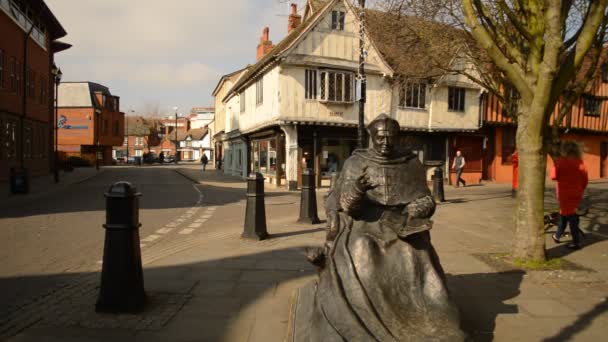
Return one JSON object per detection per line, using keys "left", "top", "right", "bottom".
{"left": 241, "top": 173, "right": 268, "bottom": 241}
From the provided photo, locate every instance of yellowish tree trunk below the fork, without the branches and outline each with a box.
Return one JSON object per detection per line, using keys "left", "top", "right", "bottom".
{"left": 513, "top": 111, "right": 547, "bottom": 261}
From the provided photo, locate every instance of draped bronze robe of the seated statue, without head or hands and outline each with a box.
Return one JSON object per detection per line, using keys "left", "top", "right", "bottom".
{"left": 310, "top": 150, "right": 464, "bottom": 342}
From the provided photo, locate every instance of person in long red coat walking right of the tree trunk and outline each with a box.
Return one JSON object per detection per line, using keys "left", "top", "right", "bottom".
{"left": 551, "top": 141, "right": 588, "bottom": 249}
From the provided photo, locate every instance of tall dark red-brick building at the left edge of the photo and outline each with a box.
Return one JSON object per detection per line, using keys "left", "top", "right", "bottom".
{"left": 0, "top": 0, "right": 70, "bottom": 182}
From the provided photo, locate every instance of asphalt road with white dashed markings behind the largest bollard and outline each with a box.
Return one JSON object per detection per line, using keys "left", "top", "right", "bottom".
{"left": 0, "top": 167, "right": 202, "bottom": 314}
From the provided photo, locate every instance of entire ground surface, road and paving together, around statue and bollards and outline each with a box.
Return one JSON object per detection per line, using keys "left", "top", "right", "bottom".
{"left": 0, "top": 165, "right": 608, "bottom": 342}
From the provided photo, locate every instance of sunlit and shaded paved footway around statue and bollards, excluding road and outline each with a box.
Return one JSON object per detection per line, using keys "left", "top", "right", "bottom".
{"left": 2, "top": 170, "right": 608, "bottom": 342}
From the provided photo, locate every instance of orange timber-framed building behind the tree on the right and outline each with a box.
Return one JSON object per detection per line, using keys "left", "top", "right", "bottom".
{"left": 448, "top": 55, "right": 608, "bottom": 183}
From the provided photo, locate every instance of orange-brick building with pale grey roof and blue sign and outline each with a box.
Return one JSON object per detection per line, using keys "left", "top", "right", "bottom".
{"left": 57, "top": 82, "right": 124, "bottom": 165}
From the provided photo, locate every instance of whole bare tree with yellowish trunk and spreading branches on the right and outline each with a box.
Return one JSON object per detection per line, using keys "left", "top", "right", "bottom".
{"left": 373, "top": 0, "right": 608, "bottom": 260}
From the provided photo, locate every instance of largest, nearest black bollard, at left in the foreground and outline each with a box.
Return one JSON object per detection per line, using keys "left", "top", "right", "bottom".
{"left": 95, "top": 182, "right": 146, "bottom": 313}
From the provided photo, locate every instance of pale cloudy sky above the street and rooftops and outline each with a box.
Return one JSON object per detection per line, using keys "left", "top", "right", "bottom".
{"left": 46, "top": 0, "right": 305, "bottom": 114}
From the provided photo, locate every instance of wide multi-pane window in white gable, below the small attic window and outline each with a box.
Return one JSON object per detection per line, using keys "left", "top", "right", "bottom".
{"left": 319, "top": 69, "right": 355, "bottom": 104}
